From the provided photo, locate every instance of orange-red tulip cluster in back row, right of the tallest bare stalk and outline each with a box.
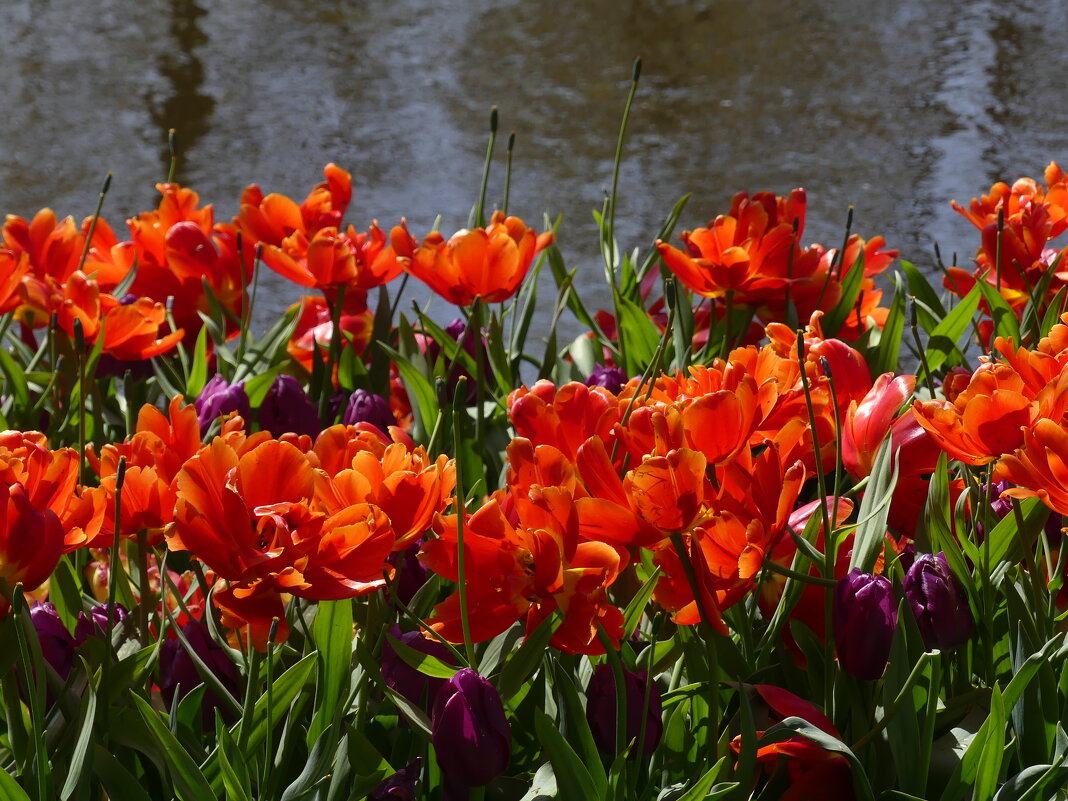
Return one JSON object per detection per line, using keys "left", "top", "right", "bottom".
{"left": 657, "top": 189, "right": 897, "bottom": 341}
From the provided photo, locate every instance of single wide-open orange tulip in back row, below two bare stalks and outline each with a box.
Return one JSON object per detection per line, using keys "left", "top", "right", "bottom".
{"left": 406, "top": 211, "right": 553, "bottom": 305}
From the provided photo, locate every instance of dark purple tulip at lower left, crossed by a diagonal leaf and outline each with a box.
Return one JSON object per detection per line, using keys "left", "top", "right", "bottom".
{"left": 159, "top": 621, "right": 238, "bottom": 728}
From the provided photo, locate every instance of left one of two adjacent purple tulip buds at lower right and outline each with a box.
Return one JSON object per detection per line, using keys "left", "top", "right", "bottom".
{"left": 832, "top": 568, "right": 897, "bottom": 679}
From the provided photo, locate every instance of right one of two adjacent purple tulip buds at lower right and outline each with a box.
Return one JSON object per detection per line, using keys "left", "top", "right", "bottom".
{"left": 901, "top": 553, "right": 972, "bottom": 650}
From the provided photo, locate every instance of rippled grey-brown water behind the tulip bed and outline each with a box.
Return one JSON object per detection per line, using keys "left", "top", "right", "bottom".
{"left": 0, "top": 0, "right": 1068, "bottom": 333}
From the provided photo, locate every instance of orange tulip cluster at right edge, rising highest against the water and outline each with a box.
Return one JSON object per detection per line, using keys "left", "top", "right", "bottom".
{"left": 945, "top": 161, "right": 1068, "bottom": 314}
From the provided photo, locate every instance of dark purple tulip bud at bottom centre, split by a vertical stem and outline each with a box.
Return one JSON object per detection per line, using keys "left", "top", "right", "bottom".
{"left": 586, "top": 664, "right": 664, "bottom": 759}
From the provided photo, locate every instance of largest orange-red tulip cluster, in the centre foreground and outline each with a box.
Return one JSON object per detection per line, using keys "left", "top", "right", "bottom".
{"left": 420, "top": 316, "right": 896, "bottom": 654}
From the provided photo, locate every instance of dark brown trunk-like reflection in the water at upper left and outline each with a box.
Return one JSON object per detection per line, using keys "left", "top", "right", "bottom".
{"left": 148, "top": 0, "right": 215, "bottom": 174}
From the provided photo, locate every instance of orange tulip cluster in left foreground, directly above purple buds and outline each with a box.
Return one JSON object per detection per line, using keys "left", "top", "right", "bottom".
{"left": 166, "top": 417, "right": 455, "bottom": 645}
